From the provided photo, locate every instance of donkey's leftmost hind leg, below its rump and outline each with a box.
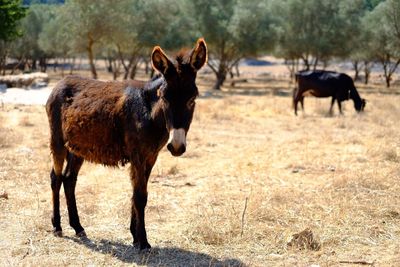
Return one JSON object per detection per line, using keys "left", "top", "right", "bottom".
{"left": 50, "top": 136, "right": 67, "bottom": 236}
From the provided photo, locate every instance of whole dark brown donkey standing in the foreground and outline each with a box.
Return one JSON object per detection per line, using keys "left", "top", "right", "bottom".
{"left": 46, "top": 39, "right": 207, "bottom": 249}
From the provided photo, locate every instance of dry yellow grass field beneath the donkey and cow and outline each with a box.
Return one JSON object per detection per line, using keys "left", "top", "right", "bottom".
{"left": 0, "top": 63, "right": 400, "bottom": 266}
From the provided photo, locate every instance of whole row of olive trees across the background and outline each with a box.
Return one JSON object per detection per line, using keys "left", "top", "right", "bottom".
{"left": 0, "top": 0, "right": 400, "bottom": 89}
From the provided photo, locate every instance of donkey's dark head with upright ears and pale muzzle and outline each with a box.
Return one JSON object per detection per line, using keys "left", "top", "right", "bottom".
{"left": 151, "top": 38, "right": 207, "bottom": 156}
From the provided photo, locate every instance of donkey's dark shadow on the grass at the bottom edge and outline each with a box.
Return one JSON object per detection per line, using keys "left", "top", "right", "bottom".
{"left": 64, "top": 237, "right": 245, "bottom": 266}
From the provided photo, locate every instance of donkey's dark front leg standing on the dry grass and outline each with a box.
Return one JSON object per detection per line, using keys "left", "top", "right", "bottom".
{"left": 130, "top": 162, "right": 151, "bottom": 249}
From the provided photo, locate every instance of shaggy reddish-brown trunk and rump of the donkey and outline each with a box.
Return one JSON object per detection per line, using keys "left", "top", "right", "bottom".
{"left": 46, "top": 76, "right": 142, "bottom": 166}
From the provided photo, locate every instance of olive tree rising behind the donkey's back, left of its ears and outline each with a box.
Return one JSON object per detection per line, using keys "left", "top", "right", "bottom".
{"left": 106, "top": 0, "right": 197, "bottom": 79}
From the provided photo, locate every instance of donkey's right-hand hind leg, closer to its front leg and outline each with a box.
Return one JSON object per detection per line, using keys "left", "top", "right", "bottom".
{"left": 63, "top": 153, "right": 86, "bottom": 237}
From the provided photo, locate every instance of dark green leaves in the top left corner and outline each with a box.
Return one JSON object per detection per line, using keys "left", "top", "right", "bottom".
{"left": 0, "top": 0, "right": 26, "bottom": 41}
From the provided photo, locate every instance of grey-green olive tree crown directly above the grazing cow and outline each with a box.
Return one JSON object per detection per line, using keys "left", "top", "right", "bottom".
{"left": 275, "top": 0, "right": 363, "bottom": 67}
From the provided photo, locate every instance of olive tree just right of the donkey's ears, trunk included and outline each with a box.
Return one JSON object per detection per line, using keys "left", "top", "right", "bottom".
{"left": 192, "top": 0, "right": 275, "bottom": 89}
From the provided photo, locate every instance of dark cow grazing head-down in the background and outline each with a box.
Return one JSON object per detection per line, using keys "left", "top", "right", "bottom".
{"left": 293, "top": 70, "right": 365, "bottom": 115}
